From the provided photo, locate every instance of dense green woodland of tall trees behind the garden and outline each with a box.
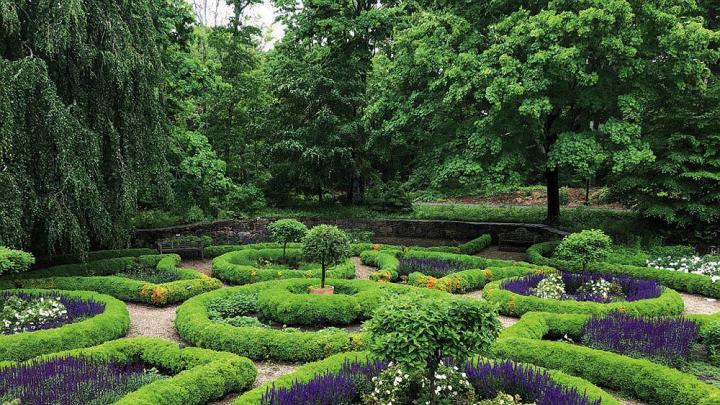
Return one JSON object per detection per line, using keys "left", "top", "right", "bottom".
{"left": 0, "top": 0, "right": 720, "bottom": 253}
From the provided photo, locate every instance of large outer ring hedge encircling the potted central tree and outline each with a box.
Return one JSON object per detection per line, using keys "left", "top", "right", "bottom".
{"left": 175, "top": 279, "right": 448, "bottom": 362}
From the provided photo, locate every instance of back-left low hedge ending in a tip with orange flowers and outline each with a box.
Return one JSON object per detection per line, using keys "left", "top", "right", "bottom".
{"left": 0, "top": 254, "right": 222, "bottom": 306}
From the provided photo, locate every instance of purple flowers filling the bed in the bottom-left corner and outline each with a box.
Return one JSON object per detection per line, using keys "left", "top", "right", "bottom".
{"left": 0, "top": 357, "right": 164, "bottom": 405}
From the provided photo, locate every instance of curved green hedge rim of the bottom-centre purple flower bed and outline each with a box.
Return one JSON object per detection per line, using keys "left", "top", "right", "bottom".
{"left": 232, "top": 352, "right": 620, "bottom": 405}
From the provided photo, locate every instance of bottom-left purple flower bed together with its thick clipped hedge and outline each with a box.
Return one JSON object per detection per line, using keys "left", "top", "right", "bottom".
{"left": 0, "top": 338, "right": 256, "bottom": 405}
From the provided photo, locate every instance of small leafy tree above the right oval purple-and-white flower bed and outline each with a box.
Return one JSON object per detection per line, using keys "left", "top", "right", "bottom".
{"left": 555, "top": 229, "right": 612, "bottom": 271}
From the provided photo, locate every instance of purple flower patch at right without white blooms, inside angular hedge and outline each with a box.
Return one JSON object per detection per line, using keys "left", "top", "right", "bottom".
{"left": 582, "top": 313, "right": 699, "bottom": 364}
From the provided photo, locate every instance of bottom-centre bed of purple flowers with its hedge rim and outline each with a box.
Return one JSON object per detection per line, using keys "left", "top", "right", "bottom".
{"left": 233, "top": 352, "right": 618, "bottom": 405}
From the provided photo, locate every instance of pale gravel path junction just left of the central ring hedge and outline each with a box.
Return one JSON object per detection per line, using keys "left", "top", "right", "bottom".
{"left": 126, "top": 302, "right": 182, "bottom": 343}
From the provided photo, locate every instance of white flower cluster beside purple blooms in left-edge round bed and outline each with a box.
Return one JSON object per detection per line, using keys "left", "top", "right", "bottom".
{"left": 0, "top": 296, "right": 67, "bottom": 333}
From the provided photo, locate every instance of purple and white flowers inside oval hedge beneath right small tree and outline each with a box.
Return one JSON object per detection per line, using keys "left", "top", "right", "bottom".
{"left": 501, "top": 272, "right": 662, "bottom": 303}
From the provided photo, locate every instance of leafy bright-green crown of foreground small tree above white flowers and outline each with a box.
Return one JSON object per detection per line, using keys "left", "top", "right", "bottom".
{"left": 365, "top": 294, "right": 501, "bottom": 375}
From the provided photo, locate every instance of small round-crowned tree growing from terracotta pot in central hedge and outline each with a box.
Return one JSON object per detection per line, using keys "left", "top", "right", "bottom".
{"left": 303, "top": 225, "right": 350, "bottom": 288}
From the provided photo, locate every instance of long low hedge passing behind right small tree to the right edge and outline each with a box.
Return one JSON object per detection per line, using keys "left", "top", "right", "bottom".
{"left": 527, "top": 241, "right": 720, "bottom": 298}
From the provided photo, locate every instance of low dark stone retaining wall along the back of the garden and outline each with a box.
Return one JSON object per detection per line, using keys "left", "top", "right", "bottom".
{"left": 134, "top": 218, "right": 566, "bottom": 247}
